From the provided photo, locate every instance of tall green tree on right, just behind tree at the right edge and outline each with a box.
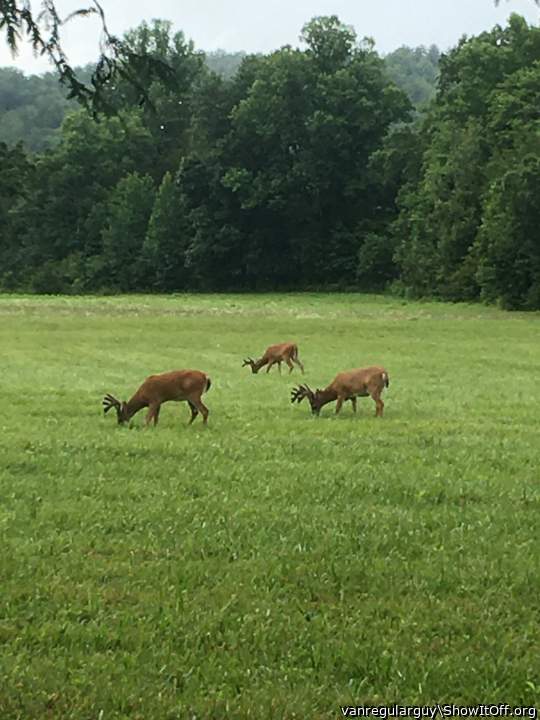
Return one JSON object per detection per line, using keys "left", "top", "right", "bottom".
{"left": 396, "top": 15, "right": 540, "bottom": 300}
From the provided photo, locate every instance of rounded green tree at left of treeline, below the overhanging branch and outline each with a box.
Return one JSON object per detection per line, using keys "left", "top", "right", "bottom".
{"left": 7, "top": 111, "right": 154, "bottom": 292}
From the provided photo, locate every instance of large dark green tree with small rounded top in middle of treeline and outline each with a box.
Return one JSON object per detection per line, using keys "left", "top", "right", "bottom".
{"left": 182, "top": 17, "right": 410, "bottom": 287}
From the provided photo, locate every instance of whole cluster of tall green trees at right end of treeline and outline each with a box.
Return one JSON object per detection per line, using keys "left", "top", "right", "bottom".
{"left": 394, "top": 15, "right": 540, "bottom": 308}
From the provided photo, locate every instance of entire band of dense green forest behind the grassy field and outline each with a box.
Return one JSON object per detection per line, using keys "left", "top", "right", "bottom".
{"left": 0, "top": 15, "right": 540, "bottom": 309}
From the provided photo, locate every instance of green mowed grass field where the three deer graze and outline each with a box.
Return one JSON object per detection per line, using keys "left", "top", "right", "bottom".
{"left": 0, "top": 294, "right": 540, "bottom": 720}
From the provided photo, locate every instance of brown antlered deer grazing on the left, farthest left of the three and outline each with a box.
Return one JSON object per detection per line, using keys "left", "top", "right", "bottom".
{"left": 103, "top": 370, "right": 212, "bottom": 425}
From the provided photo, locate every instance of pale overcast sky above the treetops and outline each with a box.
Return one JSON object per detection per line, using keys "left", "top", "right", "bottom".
{"left": 0, "top": 0, "right": 540, "bottom": 72}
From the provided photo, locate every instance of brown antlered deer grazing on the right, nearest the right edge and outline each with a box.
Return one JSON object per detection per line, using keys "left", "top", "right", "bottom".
{"left": 291, "top": 366, "right": 390, "bottom": 417}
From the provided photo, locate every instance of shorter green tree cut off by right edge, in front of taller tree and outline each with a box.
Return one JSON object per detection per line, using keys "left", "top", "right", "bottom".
{"left": 473, "top": 61, "right": 540, "bottom": 309}
